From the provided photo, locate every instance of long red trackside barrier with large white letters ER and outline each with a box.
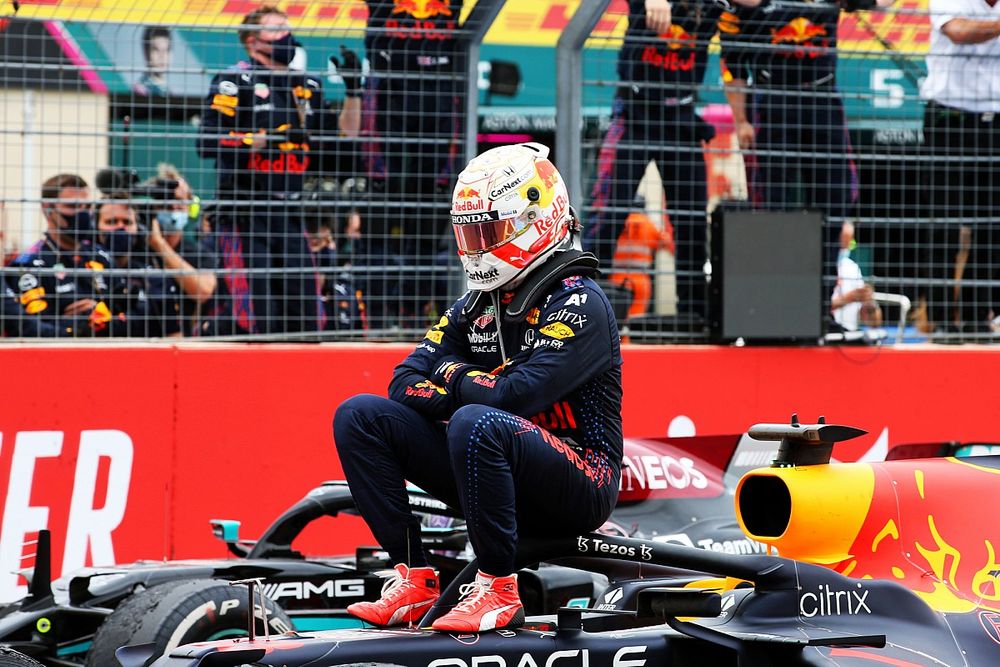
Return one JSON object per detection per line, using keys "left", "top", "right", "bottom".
{"left": 0, "top": 345, "right": 1000, "bottom": 600}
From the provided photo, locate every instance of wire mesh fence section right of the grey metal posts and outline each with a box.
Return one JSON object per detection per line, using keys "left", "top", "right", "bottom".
{"left": 580, "top": 1, "right": 1000, "bottom": 342}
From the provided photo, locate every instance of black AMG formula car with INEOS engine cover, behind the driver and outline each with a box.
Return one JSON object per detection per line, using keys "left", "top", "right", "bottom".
{"left": 0, "top": 435, "right": 775, "bottom": 667}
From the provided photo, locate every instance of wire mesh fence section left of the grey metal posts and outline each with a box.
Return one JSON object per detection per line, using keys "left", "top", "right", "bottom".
{"left": 0, "top": 0, "right": 480, "bottom": 340}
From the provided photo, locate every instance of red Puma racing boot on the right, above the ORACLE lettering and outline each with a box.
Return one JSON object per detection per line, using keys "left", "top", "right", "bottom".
{"left": 431, "top": 572, "right": 524, "bottom": 632}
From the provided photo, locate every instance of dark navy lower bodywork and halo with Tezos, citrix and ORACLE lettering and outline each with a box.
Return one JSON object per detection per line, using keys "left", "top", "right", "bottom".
{"left": 137, "top": 534, "right": 1000, "bottom": 667}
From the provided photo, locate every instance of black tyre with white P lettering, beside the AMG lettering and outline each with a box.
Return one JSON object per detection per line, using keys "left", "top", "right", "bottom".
{"left": 86, "top": 579, "right": 292, "bottom": 667}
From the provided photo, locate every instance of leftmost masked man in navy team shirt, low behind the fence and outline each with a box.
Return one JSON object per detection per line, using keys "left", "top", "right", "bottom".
{"left": 0, "top": 174, "right": 120, "bottom": 338}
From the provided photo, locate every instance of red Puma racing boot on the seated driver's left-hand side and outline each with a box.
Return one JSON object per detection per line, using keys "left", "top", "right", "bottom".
{"left": 347, "top": 563, "right": 441, "bottom": 626}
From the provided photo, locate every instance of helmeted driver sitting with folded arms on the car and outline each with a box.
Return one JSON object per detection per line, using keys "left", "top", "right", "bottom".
{"left": 333, "top": 143, "right": 622, "bottom": 632}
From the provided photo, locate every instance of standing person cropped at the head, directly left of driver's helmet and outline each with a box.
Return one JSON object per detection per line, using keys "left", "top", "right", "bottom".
{"left": 361, "top": 0, "right": 465, "bottom": 330}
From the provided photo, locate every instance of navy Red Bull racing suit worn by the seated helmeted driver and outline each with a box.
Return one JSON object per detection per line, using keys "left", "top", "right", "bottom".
{"left": 334, "top": 258, "right": 622, "bottom": 576}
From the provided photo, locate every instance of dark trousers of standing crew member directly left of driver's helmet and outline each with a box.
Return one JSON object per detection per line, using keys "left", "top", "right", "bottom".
{"left": 361, "top": 70, "right": 465, "bottom": 329}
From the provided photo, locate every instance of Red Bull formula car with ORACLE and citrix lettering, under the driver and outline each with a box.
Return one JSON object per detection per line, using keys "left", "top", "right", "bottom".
{"left": 135, "top": 422, "right": 1000, "bottom": 667}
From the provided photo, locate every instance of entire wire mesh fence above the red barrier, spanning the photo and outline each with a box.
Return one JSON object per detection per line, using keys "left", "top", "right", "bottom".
{"left": 0, "top": 0, "right": 1000, "bottom": 342}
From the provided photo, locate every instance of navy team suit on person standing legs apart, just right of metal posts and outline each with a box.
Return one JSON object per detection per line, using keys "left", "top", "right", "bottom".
{"left": 585, "top": 0, "right": 723, "bottom": 315}
